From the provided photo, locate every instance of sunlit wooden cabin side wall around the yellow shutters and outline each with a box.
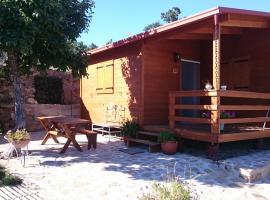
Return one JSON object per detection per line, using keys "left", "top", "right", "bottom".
{"left": 81, "top": 43, "right": 141, "bottom": 123}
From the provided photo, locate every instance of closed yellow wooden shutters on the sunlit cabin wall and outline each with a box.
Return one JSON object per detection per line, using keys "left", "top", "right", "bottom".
{"left": 96, "top": 64, "right": 114, "bottom": 94}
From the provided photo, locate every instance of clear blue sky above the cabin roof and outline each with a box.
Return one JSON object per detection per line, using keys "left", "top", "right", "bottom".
{"left": 78, "top": 0, "right": 270, "bottom": 46}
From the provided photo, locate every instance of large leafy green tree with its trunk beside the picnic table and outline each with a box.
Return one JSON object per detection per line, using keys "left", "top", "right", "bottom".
{"left": 0, "top": 0, "right": 94, "bottom": 129}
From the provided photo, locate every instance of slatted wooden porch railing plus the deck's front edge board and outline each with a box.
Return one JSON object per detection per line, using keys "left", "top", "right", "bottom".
{"left": 169, "top": 90, "right": 270, "bottom": 143}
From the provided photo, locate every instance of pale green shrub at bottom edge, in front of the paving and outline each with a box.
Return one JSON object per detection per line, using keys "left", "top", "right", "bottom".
{"left": 139, "top": 180, "right": 191, "bottom": 200}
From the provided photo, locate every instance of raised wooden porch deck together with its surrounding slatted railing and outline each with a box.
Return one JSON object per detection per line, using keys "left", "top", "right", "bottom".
{"left": 169, "top": 90, "right": 270, "bottom": 144}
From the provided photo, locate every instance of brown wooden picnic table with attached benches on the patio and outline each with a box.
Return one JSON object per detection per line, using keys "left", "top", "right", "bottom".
{"left": 38, "top": 116, "right": 97, "bottom": 153}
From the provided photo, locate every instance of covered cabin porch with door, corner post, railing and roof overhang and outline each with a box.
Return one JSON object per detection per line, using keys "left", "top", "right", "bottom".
{"left": 143, "top": 8, "right": 270, "bottom": 155}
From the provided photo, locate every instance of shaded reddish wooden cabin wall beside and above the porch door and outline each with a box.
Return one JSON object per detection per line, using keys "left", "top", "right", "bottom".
{"left": 143, "top": 40, "right": 200, "bottom": 125}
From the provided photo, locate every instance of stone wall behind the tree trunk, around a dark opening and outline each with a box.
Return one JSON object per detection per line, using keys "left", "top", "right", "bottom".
{"left": 0, "top": 70, "right": 80, "bottom": 131}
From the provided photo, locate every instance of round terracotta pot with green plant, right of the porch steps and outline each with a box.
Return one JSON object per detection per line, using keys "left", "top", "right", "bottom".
{"left": 159, "top": 131, "right": 178, "bottom": 155}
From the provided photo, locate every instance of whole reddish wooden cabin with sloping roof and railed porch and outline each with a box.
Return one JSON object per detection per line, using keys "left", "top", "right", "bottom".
{"left": 81, "top": 7, "right": 270, "bottom": 155}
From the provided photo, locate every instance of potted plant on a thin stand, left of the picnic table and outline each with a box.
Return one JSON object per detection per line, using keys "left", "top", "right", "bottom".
{"left": 6, "top": 129, "right": 30, "bottom": 148}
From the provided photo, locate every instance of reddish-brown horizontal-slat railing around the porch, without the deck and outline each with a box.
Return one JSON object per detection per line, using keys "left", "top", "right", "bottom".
{"left": 169, "top": 90, "right": 270, "bottom": 141}
